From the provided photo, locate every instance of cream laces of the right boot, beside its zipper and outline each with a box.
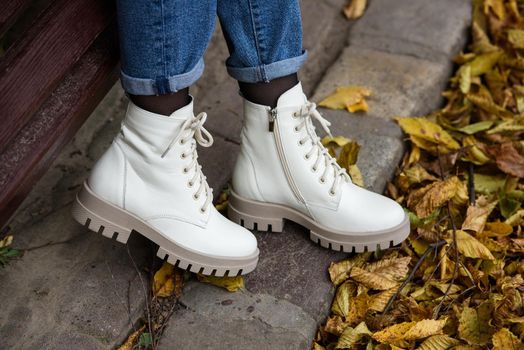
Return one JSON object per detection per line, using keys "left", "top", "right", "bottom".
{"left": 293, "top": 102, "right": 351, "bottom": 196}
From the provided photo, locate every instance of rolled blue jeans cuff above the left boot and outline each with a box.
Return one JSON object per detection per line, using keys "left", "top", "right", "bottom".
{"left": 120, "top": 58, "right": 204, "bottom": 95}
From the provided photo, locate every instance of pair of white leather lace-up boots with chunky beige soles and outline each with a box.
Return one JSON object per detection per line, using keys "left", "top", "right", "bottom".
{"left": 73, "top": 84, "right": 409, "bottom": 276}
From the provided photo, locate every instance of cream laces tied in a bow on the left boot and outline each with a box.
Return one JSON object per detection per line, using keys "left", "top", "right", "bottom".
{"left": 162, "top": 112, "right": 213, "bottom": 213}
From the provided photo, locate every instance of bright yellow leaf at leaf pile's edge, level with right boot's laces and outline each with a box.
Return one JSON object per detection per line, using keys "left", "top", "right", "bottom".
{"left": 395, "top": 117, "right": 460, "bottom": 154}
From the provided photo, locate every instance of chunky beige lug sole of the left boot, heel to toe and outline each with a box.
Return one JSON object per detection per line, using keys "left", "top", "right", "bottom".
{"left": 71, "top": 182, "right": 259, "bottom": 276}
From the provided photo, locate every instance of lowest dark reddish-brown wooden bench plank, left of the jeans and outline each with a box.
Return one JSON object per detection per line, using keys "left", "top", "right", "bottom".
{"left": 0, "top": 25, "right": 118, "bottom": 227}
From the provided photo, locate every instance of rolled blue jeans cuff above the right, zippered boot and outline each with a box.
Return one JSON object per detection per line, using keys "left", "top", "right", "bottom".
{"left": 227, "top": 50, "right": 307, "bottom": 83}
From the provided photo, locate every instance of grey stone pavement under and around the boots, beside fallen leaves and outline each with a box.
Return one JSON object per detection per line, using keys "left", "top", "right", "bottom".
{"left": 0, "top": 0, "right": 470, "bottom": 349}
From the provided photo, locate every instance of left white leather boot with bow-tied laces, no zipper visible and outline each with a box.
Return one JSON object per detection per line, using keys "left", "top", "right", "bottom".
{"left": 72, "top": 102, "right": 258, "bottom": 276}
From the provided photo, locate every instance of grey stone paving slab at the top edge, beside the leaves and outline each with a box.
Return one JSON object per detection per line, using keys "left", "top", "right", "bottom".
{"left": 349, "top": 0, "right": 471, "bottom": 64}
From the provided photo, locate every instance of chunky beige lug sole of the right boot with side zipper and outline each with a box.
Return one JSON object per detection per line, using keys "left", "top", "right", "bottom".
{"left": 228, "top": 191, "right": 410, "bottom": 253}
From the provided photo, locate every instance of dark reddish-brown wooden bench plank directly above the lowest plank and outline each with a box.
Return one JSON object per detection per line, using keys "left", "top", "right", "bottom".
{"left": 0, "top": 0, "right": 114, "bottom": 151}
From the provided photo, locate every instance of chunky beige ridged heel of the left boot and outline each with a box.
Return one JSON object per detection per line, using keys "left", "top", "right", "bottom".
{"left": 71, "top": 191, "right": 131, "bottom": 243}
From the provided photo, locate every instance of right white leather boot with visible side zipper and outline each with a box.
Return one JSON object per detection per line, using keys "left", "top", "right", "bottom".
{"left": 228, "top": 83, "right": 409, "bottom": 252}
